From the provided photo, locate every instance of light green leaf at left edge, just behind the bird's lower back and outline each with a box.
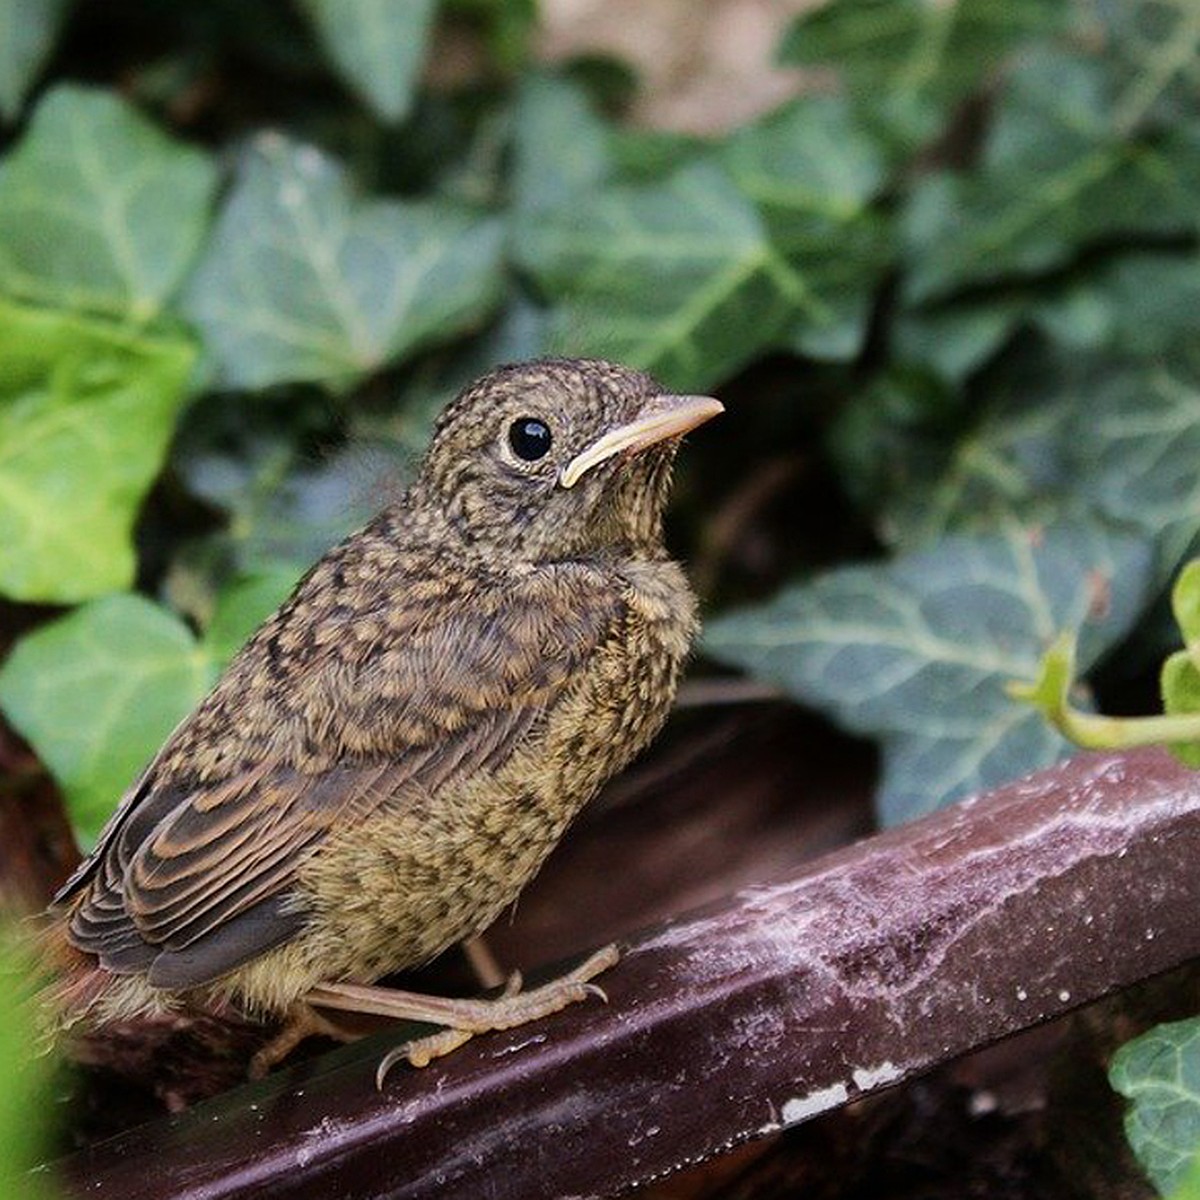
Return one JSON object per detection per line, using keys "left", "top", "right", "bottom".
{"left": 0, "top": 595, "right": 215, "bottom": 845}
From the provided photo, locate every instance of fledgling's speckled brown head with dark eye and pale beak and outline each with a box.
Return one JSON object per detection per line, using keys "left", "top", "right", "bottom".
{"left": 418, "top": 359, "right": 722, "bottom": 562}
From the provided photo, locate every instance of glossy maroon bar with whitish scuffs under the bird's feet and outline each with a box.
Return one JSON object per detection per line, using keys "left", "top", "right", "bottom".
{"left": 51, "top": 751, "right": 1200, "bottom": 1200}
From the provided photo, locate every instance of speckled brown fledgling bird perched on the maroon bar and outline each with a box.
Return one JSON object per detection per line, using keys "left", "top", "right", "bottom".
{"left": 48, "top": 358, "right": 722, "bottom": 1086}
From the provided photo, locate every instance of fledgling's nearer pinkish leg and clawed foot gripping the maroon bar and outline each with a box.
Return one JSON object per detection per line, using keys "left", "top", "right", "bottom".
{"left": 305, "top": 946, "right": 620, "bottom": 1086}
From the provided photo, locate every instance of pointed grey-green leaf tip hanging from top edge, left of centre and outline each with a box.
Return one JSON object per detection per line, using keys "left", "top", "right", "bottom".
{"left": 301, "top": 0, "right": 437, "bottom": 121}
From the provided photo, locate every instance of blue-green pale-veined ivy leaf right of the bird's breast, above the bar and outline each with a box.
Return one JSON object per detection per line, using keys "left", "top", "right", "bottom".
{"left": 704, "top": 522, "right": 1150, "bottom": 823}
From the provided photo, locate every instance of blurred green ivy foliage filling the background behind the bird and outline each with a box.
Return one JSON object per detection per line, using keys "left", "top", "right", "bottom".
{"left": 0, "top": 0, "right": 1200, "bottom": 1187}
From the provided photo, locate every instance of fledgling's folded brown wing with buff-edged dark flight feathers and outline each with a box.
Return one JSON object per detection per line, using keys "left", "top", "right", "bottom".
{"left": 56, "top": 568, "right": 624, "bottom": 988}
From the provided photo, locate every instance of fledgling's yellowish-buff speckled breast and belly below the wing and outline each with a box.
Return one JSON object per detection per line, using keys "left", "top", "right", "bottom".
{"left": 290, "top": 552, "right": 696, "bottom": 980}
